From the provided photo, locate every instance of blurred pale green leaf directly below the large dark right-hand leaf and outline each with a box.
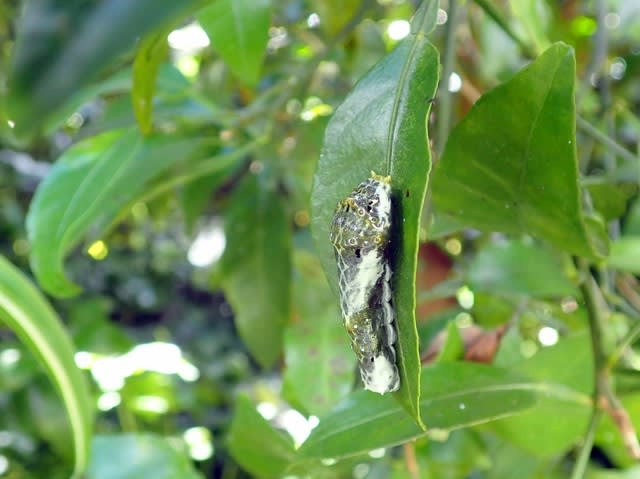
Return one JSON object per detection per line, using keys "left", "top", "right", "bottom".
{"left": 467, "top": 241, "right": 577, "bottom": 297}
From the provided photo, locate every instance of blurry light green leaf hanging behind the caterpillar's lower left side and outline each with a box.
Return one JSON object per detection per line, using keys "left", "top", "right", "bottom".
{"left": 283, "top": 251, "right": 354, "bottom": 416}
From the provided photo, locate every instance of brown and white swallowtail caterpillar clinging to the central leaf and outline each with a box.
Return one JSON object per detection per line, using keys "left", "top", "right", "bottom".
{"left": 329, "top": 172, "right": 400, "bottom": 394}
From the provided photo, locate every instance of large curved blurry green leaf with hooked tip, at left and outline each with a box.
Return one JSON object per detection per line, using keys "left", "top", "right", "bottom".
{"left": 27, "top": 131, "right": 212, "bottom": 297}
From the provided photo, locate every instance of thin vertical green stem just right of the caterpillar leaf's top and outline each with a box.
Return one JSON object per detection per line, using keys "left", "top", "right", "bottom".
{"left": 436, "top": 0, "right": 458, "bottom": 157}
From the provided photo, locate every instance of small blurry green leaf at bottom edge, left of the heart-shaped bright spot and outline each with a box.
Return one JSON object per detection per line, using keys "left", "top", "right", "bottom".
{"left": 229, "top": 396, "right": 294, "bottom": 478}
